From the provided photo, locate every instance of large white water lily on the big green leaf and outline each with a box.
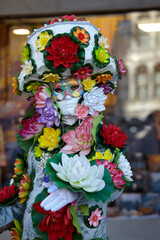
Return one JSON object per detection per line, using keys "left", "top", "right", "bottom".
{"left": 51, "top": 153, "right": 105, "bottom": 192}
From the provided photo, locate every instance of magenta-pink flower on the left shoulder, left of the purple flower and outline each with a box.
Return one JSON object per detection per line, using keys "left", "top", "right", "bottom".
{"left": 19, "top": 112, "right": 44, "bottom": 139}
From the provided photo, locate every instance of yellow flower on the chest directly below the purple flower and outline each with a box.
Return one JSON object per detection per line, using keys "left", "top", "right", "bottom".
{"left": 38, "top": 128, "right": 61, "bottom": 151}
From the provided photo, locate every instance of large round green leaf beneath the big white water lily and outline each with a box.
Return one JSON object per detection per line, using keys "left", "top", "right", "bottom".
{"left": 45, "top": 153, "right": 114, "bottom": 202}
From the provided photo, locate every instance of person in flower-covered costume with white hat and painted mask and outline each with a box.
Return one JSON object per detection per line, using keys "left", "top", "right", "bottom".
{"left": 0, "top": 15, "right": 132, "bottom": 240}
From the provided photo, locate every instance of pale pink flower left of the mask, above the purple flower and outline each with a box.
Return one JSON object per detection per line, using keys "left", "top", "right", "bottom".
{"left": 34, "top": 85, "right": 51, "bottom": 108}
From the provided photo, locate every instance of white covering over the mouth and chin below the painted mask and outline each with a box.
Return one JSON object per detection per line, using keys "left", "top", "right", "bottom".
{"left": 57, "top": 96, "right": 81, "bottom": 116}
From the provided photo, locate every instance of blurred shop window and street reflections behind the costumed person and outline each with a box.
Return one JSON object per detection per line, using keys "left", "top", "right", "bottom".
{"left": 0, "top": 0, "right": 160, "bottom": 240}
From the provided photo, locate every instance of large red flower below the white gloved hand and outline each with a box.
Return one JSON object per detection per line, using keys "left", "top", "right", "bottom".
{"left": 33, "top": 202, "right": 75, "bottom": 240}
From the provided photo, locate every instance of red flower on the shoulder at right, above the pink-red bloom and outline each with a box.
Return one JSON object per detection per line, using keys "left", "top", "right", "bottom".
{"left": 101, "top": 124, "right": 128, "bottom": 148}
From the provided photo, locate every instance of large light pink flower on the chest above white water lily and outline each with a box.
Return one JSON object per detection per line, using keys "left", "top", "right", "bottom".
{"left": 60, "top": 116, "right": 94, "bottom": 155}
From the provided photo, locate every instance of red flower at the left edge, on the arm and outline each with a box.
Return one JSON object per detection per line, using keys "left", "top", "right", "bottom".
{"left": 0, "top": 184, "right": 17, "bottom": 204}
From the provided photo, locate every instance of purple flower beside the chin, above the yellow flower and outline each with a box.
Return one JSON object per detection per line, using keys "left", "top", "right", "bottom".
{"left": 37, "top": 98, "right": 59, "bottom": 128}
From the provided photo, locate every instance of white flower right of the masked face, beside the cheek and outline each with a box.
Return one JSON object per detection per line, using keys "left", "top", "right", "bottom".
{"left": 83, "top": 87, "right": 107, "bottom": 115}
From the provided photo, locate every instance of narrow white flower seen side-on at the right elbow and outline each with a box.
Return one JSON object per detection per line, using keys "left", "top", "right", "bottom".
{"left": 118, "top": 154, "right": 133, "bottom": 181}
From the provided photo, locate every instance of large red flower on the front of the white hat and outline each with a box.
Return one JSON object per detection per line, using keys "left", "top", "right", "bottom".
{"left": 46, "top": 36, "right": 79, "bottom": 68}
